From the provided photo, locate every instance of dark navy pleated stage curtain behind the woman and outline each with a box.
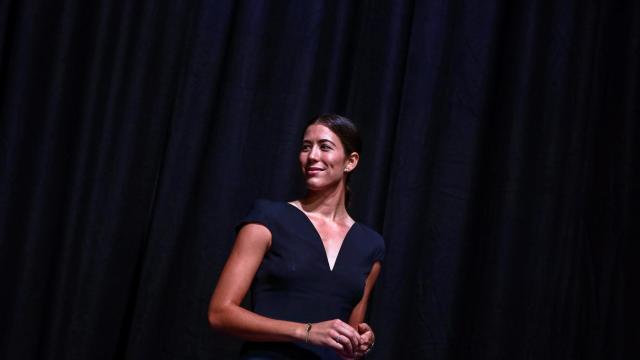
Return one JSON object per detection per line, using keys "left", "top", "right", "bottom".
{"left": 0, "top": 0, "right": 640, "bottom": 359}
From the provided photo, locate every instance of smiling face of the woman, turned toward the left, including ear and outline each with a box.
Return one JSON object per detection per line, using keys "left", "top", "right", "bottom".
{"left": 300, "top": 124, "right": 358, "bottom": 190}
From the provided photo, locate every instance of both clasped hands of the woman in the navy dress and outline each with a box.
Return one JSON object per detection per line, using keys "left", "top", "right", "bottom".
{"left": 309, "top": 319, "right": 375, "bottom": 360}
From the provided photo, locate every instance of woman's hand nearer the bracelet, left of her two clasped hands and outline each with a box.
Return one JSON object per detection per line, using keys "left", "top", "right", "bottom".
{"left": 309, "top": 319, "right": 362, "bottom": 359}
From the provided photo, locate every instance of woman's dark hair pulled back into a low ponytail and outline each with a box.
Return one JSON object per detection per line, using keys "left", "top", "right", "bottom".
{"left": 305, "top": 114, "right": 362, "bottom": 206}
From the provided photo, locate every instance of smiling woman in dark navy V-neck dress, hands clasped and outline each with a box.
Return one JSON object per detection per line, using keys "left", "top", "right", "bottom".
{"left": 209, "top": 114, "right": 384, "bottom": 360}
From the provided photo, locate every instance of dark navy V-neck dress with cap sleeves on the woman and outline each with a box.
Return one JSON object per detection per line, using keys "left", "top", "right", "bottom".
{"left": 236, "top": 200, "right": 385, "bottom": 360}
